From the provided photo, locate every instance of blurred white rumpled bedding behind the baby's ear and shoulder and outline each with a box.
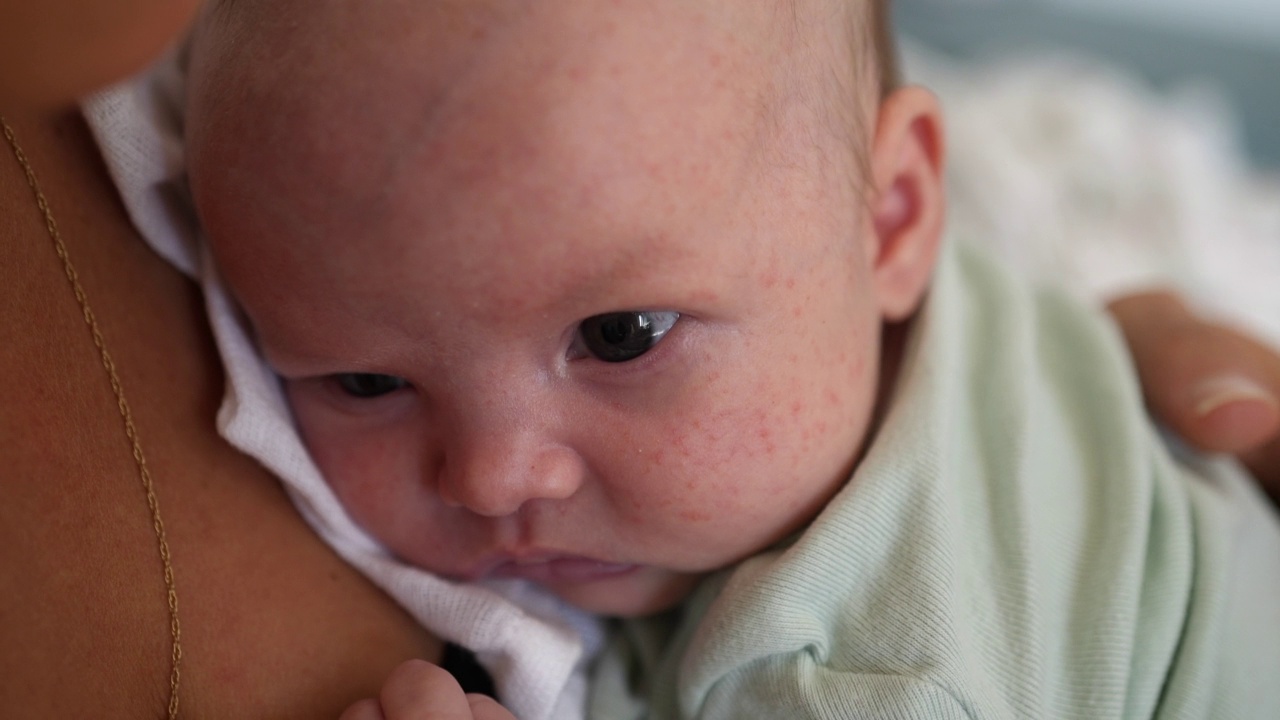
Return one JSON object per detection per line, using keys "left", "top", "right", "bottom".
{"left": 906, "top": 41, "right": 1280, "bottom": 347}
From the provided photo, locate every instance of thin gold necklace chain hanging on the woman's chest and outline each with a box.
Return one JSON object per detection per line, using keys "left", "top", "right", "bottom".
{"left": 0, "top": 115, "right": 182, "bottom": 720}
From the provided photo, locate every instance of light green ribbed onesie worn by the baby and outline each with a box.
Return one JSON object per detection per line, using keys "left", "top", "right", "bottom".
{"left": 589, "top": 239, "right": 1280, "bottom": 720}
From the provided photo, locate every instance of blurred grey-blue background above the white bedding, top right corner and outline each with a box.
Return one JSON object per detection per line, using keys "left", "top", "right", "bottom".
{"left": 895, "top": 0, "right": 1280, "bottom": 170}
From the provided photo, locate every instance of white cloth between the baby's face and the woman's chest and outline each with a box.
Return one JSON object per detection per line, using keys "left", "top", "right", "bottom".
{"left": 83, "top": 59, "right": 602, "bottom": 720}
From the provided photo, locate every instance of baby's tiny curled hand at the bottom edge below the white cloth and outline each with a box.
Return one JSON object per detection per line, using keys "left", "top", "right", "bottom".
{"left": 338, "top": 660, "right": 516, "bottom": 720}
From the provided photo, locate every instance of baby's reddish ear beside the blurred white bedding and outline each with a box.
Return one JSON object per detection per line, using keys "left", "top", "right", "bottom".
{"left": 868, "top": 87, "right": 946, "bottom": 322}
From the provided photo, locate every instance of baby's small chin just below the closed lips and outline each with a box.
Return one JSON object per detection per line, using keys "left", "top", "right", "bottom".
{"left": 543, "top": 566, "right": 705, "bottom": 618}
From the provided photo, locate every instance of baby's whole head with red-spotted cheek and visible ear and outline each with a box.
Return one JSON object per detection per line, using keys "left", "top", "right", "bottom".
{"left": 187, "top": 0, "right": 942, "bottom": 615}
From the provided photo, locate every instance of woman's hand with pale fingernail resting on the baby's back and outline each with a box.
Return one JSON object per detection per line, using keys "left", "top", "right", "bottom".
{"left": 1108, "top": 292, "right": 1280, "bottom": 502}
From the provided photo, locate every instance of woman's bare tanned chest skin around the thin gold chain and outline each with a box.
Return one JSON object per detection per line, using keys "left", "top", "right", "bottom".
{"left": 0, "top": 111, "right": 440, "bottom": 719}
